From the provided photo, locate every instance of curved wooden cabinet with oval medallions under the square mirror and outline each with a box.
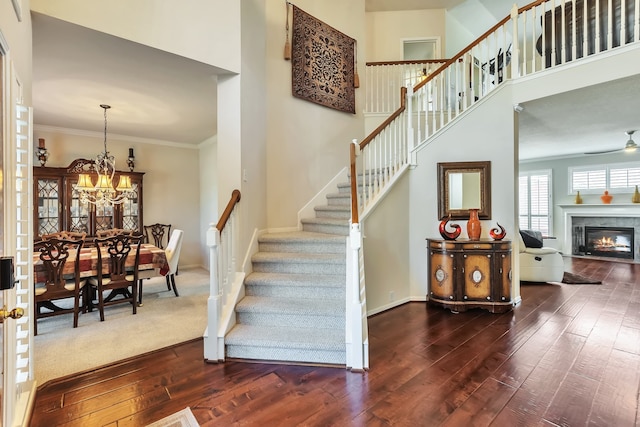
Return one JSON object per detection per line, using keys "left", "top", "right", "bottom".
{"left": 427, "top": 239, "right": 513, "bottom": 313}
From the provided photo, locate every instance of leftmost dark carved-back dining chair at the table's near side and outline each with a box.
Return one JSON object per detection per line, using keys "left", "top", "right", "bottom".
{"left": 33, "top": 238, "right": 87, "bottom": 335}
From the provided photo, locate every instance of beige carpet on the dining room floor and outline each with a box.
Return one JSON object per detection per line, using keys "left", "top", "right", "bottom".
{"left": 34, "top": 268, "right": 209, "bottom": 385}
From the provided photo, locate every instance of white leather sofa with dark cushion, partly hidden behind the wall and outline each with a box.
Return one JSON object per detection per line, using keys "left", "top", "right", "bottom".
{"left": 518, "top": 230, "right": 564, "bottom": 282}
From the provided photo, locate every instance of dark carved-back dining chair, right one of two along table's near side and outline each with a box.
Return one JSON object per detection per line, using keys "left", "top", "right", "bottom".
{"left": 89, "top": 234, "right": 143, "bottom": 321}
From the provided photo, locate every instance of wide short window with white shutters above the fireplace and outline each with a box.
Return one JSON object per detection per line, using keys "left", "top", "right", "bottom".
{"left": 569, "top": 162, "right": 640, "bottom": 194}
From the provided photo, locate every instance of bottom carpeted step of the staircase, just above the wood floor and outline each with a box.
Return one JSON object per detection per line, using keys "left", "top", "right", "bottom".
{"left": 225, "top": 324, "right": 344, "bottom": 351}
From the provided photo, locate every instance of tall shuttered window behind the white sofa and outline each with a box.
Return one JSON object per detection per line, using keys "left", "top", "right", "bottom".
{"left": 518, "top": 170, "right": 551, "bottom": 236}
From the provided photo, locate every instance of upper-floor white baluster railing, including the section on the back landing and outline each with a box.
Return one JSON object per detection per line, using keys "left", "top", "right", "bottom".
{"left": 365, "top": 0, "right": 640, "bottom": 117}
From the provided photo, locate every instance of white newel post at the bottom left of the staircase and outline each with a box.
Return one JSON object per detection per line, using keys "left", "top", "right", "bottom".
{"left": 204, "top": 223, "right": 224, "bottom": 362}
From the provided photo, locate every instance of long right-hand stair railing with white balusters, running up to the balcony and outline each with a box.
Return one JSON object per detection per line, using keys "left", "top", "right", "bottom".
{"left": 346, "top": 0, "right": 640, "bottom": 370}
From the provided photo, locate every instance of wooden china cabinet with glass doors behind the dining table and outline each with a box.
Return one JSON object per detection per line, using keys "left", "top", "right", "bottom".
{"left": 33, "top": 159, "right": 144, "bottom": 240}
